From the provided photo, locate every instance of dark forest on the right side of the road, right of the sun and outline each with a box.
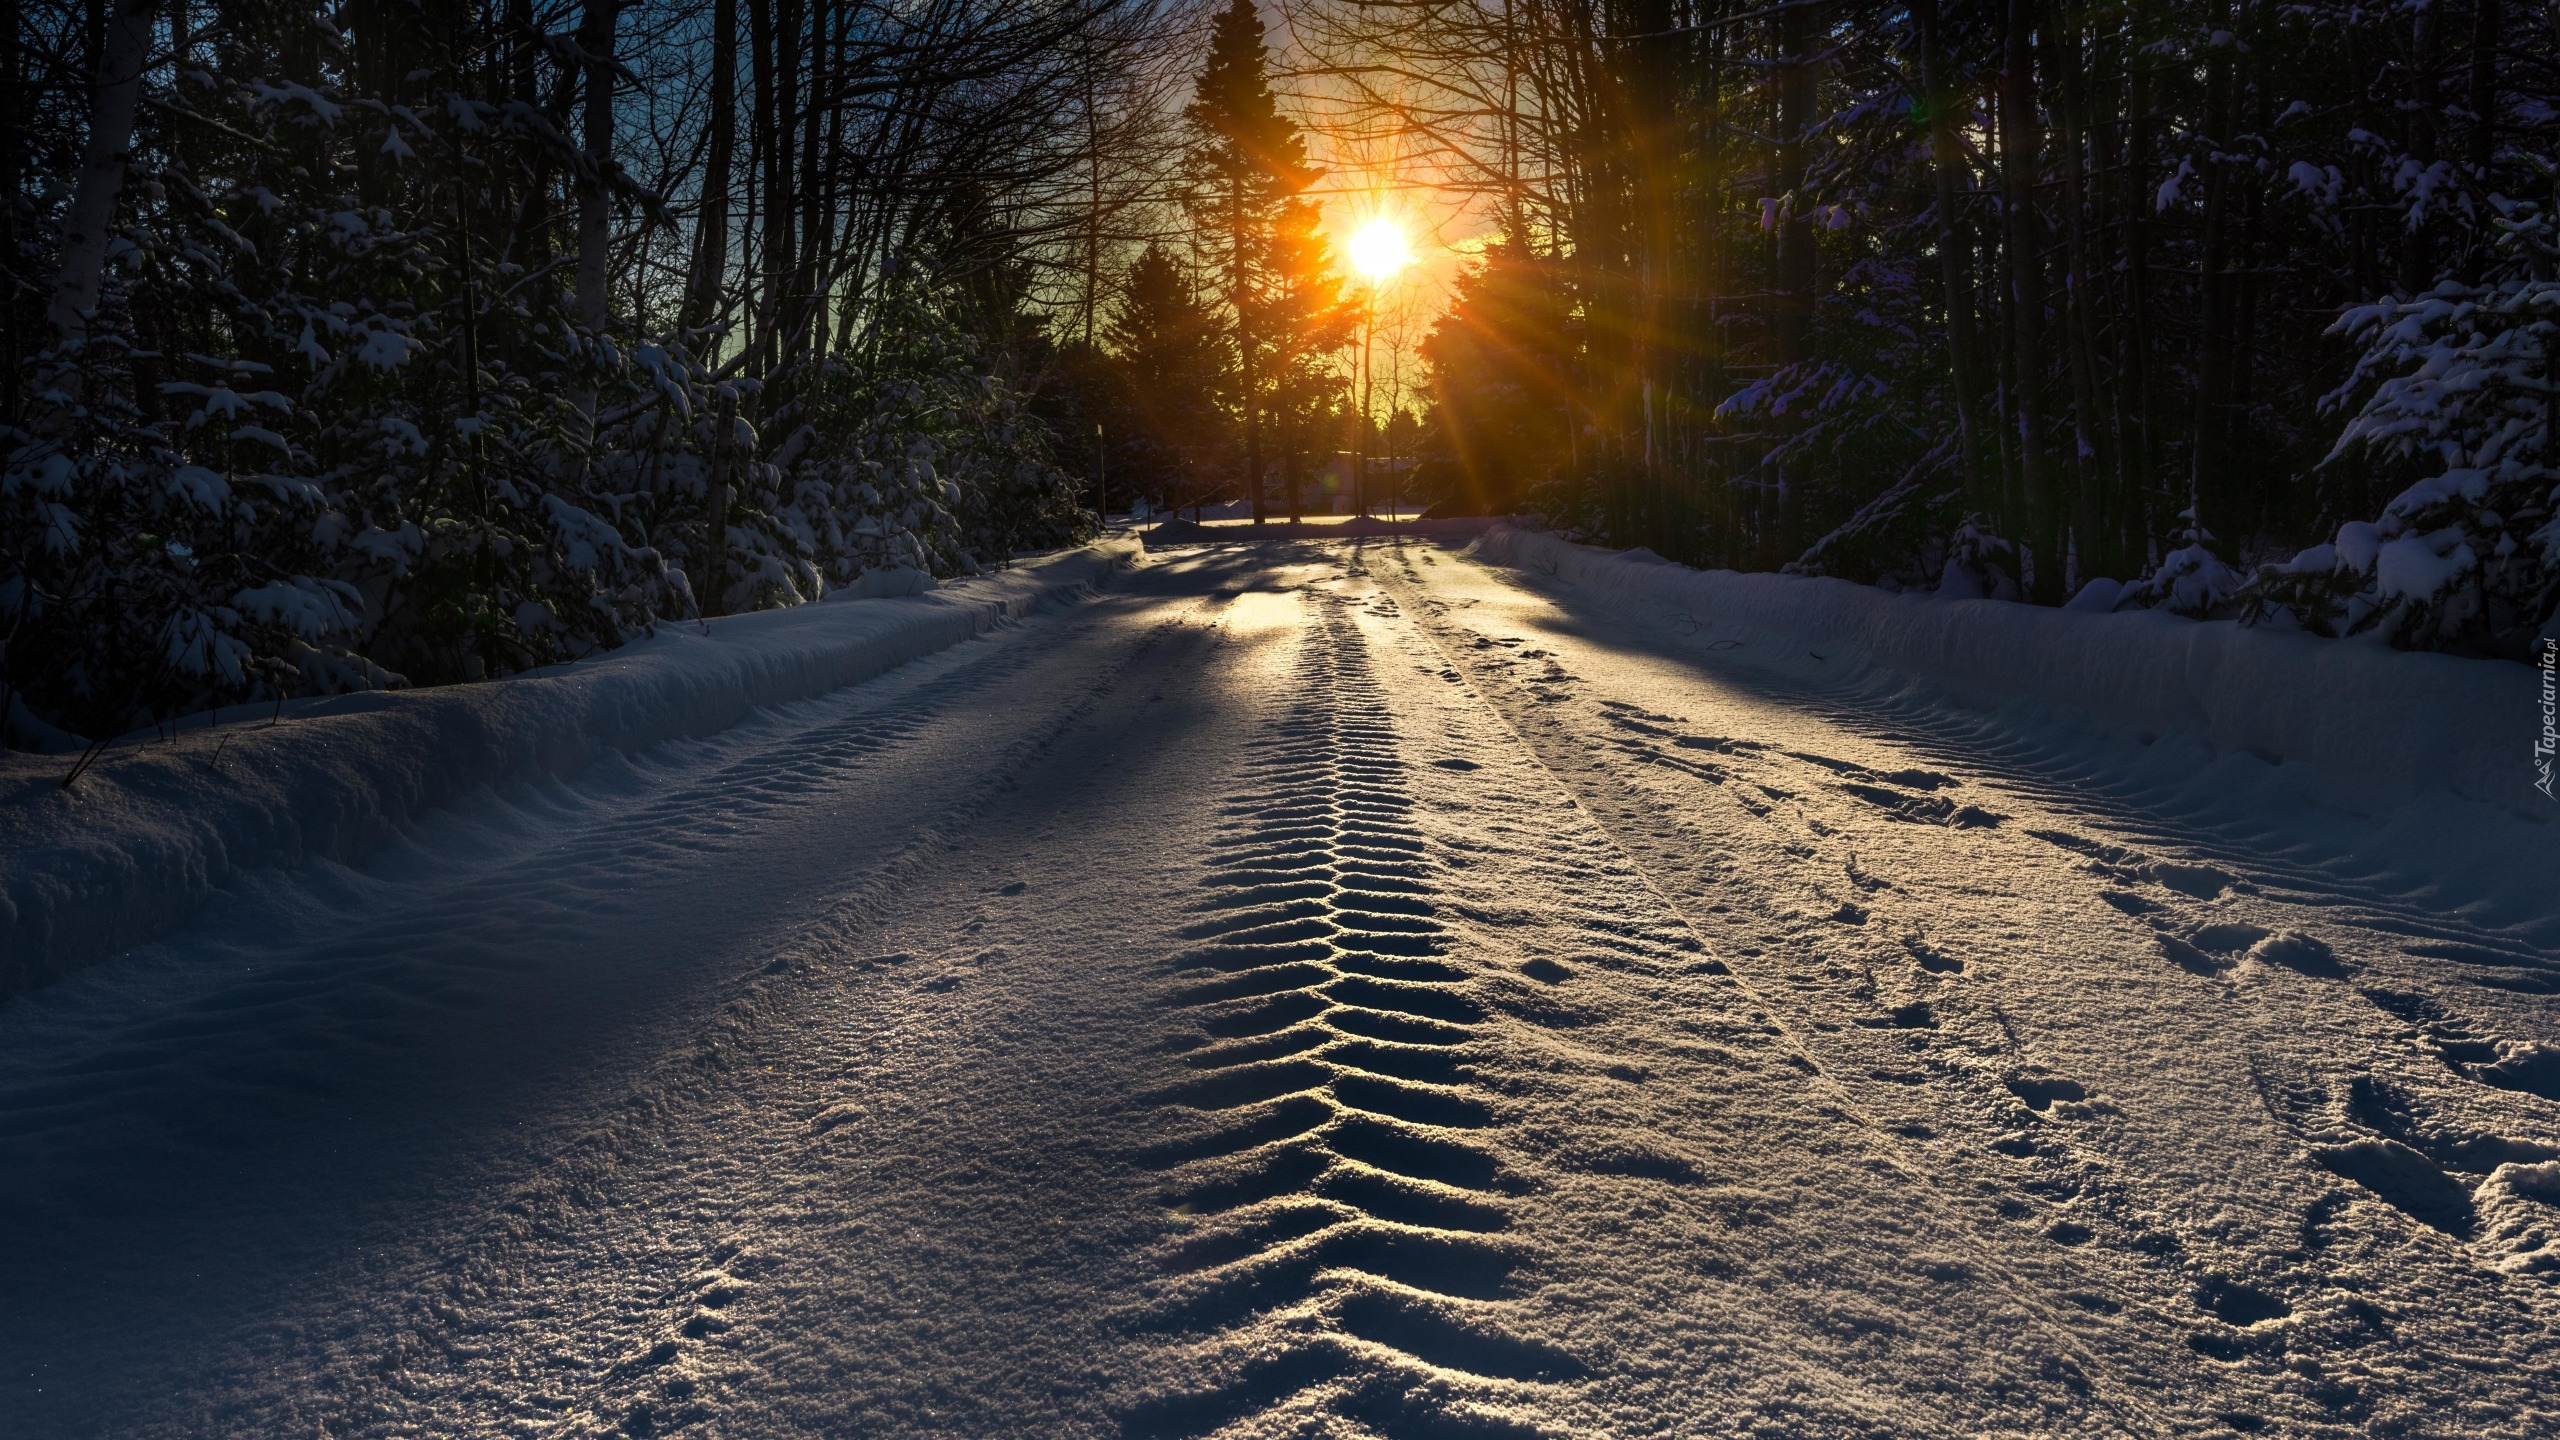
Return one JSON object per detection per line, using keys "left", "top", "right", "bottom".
{"left": 1341, "top": 0, "right": 2560, "bottom": 645}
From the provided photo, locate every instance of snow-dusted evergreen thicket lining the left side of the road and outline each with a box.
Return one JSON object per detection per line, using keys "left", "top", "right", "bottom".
{"left": 0, "top": 3, "right": 1093, "bottom": 748}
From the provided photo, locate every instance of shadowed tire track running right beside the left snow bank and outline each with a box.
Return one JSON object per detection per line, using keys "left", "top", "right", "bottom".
{"left": 0, "top": 609, "right": 1090, "bottom": 1173}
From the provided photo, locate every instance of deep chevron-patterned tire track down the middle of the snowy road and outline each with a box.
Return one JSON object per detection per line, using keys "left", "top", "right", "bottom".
{"left": 1124, "top": 591, "right": 1585, "bottom": 1437}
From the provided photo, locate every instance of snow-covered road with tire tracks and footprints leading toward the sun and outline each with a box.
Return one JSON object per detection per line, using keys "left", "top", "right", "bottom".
{"left": 0, "top": 541, "right": 2560, "bottom": 1437}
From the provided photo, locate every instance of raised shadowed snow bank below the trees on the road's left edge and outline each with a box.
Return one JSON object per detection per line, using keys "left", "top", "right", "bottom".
{"left": 0, "top": 541, "right": 1139, "bottom": 999}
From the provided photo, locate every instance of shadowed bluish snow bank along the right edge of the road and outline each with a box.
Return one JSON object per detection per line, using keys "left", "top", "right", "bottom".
{"left": 1477, "top": 525, "right": 2552, "bottom": 820}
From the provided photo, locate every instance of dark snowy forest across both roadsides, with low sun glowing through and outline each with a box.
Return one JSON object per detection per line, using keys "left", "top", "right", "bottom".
{"left": 0, "top": 0, "right": 2560, "bottom": 748}
